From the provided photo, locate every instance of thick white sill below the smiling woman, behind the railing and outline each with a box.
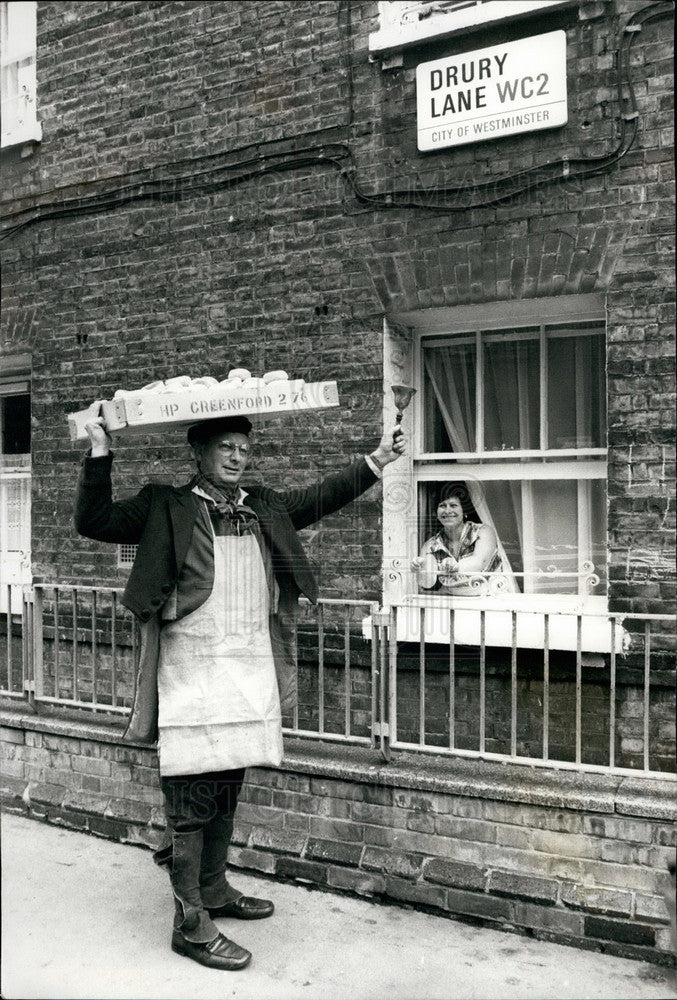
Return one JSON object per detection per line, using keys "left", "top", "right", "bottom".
{"left": 363, "top": 594, "right": 629, "bottom": 659}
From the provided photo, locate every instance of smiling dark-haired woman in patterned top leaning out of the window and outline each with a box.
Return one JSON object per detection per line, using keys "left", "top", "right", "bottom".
{"left": 412, "top": 484, "right": 502, "bottom": 595}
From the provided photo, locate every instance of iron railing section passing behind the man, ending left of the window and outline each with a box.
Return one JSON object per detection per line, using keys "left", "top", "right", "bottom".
{"left": 0, "top": 584, "right": 378, "bottom": 744}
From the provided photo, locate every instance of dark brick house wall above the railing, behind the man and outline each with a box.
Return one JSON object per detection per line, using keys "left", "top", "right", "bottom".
{"left": 2, "top": 0, "right": 675, "bottom": 612}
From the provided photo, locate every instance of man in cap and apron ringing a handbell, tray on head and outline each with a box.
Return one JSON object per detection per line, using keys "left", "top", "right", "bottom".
{"left": 75, "top": 406, "right": 404, "bottom": 969}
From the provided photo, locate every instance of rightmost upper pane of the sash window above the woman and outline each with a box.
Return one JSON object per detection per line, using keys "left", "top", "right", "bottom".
{"left": 548, "top": 335, "right": 606, "bottom": 448}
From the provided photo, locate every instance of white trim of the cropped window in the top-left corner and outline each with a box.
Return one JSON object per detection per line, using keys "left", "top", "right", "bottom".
{"left": 0, "top": 0, "right": 42, "bottom": 149}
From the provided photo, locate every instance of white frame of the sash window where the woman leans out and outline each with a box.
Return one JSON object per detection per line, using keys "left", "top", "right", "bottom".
{"left": 383, "top": 293, "right": 608, "bottom": 613}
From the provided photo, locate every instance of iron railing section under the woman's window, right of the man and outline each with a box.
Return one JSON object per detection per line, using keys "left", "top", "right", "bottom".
{"left": 378, "top": 602, "right": 677, "bottom": 778}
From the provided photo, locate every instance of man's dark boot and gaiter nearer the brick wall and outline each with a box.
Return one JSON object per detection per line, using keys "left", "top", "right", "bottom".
{"left": 200, "top": 813, "right": 275, "bottom": 920}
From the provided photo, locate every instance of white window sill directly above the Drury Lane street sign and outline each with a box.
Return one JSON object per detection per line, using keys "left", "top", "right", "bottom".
{"left": 369, "top": 0, "right": 579, "bottom": 58}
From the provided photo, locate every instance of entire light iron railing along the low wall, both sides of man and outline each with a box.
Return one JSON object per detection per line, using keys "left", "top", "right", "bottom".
{"left": 0, "top": 584, "right": 676, "bottom": 779}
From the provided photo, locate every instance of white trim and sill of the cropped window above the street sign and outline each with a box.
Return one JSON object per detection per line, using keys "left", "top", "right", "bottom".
{"left": 369, "top": 0, "right": 579, "bottom": 57}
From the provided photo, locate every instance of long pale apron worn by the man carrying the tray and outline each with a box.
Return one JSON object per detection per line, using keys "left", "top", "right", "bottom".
{"left": 158, "top": 534, "right": 282, "bottom": 776}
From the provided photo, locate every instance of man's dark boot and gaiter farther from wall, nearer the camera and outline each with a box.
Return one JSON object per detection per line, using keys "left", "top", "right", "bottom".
{"left": 171, "top": 829, "right": 251, "bottom": 970}
